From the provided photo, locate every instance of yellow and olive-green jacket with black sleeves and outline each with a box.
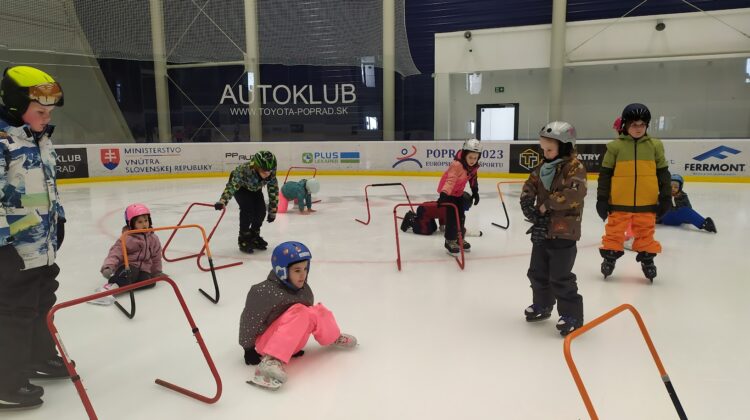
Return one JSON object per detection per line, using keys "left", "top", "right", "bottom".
{"left": 596, "top": 134, "right": 672, "bottom": 213}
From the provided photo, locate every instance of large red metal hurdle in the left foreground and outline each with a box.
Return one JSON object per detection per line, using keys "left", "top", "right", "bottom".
{"left": 47, "top": 276, "right": 222, "bottom": 420}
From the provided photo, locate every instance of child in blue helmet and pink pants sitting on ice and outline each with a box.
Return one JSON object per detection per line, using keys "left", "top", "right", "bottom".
{"left": 239, "top": 242, "right": 357, "bottom": 390}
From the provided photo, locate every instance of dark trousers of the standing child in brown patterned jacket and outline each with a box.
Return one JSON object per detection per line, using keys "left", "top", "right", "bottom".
{"left": 526, "top": 239, "right": 583, "bottom": 321}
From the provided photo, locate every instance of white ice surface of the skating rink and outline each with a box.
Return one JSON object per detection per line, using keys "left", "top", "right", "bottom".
{"left": 7, "top": 176, "right": 750, "bottom": 420}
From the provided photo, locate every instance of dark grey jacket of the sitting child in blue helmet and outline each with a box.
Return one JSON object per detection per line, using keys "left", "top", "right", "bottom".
{"left": 240, "top": 270, "right": 314, "bottom": 349}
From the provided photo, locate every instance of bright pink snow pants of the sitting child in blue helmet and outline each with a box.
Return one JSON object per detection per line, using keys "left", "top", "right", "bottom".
{"left": 255, "top": 303, "right": 341, "bottom": 363}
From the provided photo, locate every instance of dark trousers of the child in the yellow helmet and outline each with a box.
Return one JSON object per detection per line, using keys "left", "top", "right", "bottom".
{"left": 0, "top": 261, "right": 60, "bottom": 391}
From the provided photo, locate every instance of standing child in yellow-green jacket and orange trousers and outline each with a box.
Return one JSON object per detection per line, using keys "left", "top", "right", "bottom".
{"left": 596, "top": 103, "right": 672, "bottom": 282}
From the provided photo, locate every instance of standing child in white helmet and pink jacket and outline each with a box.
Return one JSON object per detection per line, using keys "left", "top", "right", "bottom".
{"left": 438, "top": 139, "right": 482, "bottom": 254}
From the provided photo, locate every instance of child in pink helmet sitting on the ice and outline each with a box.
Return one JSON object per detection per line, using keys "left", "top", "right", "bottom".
{"left": 89, "top": 204, "right": 162, "bottom": 305}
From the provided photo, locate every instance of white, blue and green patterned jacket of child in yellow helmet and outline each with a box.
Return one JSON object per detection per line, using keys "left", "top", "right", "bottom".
{"left": 0, "top": 108, "right": 65, "bottom": 270}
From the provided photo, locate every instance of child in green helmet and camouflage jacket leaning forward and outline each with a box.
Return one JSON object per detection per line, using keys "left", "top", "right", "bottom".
{"left": 214, "top": 150, "right": 279, "bottom": 254}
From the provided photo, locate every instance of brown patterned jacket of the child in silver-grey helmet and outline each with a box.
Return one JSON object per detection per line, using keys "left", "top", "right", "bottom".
{"left": 521, "top": 157, "right": 586, "bottom": 241}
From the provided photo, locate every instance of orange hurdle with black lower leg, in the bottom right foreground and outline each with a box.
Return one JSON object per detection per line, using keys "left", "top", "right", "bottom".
{"left": 563, "top": 304, "right": 687, "bottom": 420}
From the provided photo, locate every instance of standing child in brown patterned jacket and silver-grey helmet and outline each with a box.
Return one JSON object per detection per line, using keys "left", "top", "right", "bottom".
{"left": 521, "top": 121, "right": 586, "bottom": 336}
